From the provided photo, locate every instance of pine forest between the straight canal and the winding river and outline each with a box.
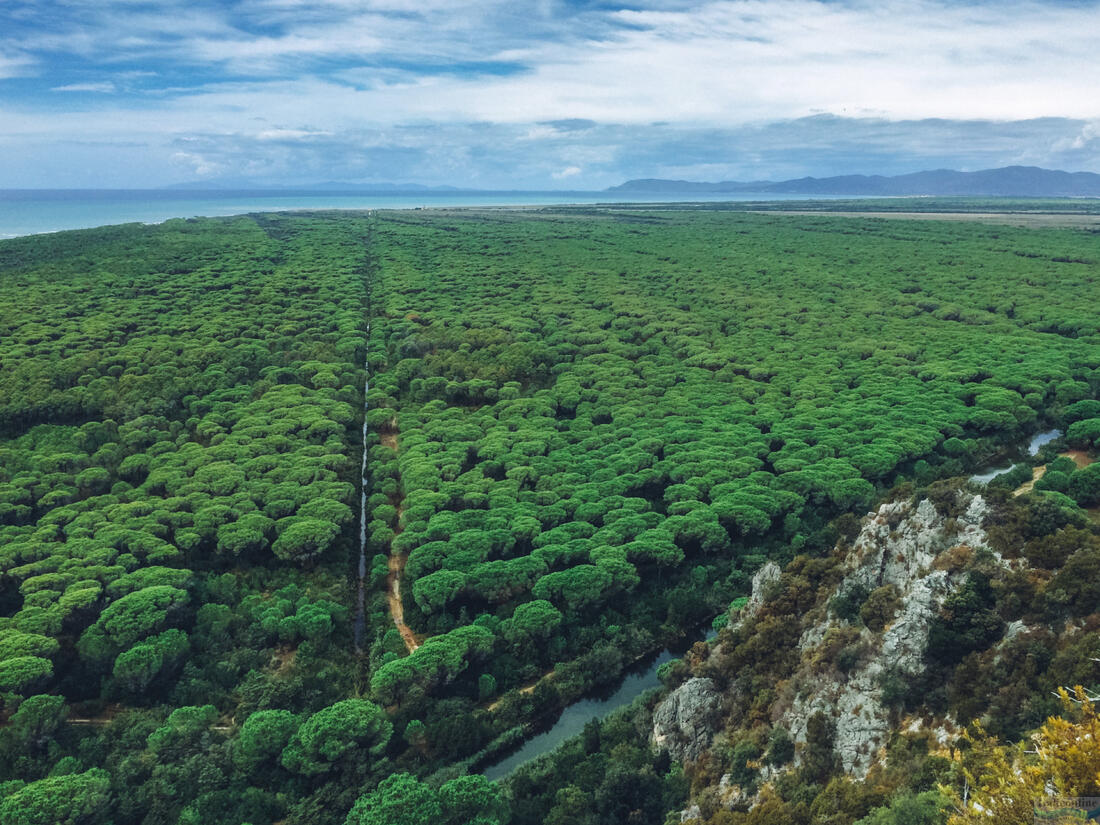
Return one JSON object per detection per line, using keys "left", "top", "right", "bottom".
{"left": 369, "top": 210, "right": 1098, "bottom": 712}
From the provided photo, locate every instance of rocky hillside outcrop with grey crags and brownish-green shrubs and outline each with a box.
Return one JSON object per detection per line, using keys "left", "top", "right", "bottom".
{"left": 655, "top": 483, "right": 1096, "bottom": 822}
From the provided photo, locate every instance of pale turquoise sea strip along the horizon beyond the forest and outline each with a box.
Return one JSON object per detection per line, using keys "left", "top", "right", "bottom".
{"left": 0, "top": 189, "right": 853, "bottom": 239}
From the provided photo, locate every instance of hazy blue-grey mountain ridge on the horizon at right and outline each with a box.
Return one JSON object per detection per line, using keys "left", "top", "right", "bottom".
{"left": 607, "top": 166, "right": 1100, "bottom": 198}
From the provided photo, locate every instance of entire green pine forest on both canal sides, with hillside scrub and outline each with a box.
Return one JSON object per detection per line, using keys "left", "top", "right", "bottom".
{"left": 0, "top": 208, "right": 1100, "bottom": 825}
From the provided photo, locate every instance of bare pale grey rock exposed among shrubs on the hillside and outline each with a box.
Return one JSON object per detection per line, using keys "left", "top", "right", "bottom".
{"left": 652, "top": 492, "right": 1003, "bottom": 821}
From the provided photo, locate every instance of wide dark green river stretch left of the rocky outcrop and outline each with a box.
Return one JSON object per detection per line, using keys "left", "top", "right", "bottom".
{"left": 482, "top": 630, "right": 717, "bottom": 780}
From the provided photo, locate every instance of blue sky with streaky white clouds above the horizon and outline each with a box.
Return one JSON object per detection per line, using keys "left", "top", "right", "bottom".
{"left": 0, "top": 0, "right": 1100, "bottom": 189}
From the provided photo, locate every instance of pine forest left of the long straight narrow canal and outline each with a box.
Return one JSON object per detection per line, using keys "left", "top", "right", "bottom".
{"left": 0, "top": 217, "right": 371, "bottom": 825}
